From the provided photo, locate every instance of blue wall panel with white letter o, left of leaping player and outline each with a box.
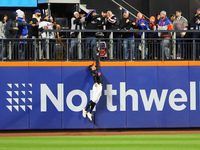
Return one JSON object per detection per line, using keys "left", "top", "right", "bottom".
{"left": 62, "top": 67, "right": 94, "bottom": 129}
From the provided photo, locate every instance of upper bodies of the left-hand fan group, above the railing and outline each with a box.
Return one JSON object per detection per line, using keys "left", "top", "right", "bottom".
{"left": 0, "top": 9, "right": 61, "bottom": 38}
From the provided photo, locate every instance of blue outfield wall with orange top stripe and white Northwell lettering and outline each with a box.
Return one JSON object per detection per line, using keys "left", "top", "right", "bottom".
{"left": 0, "top": 62, "right": 200, "bottom": 130}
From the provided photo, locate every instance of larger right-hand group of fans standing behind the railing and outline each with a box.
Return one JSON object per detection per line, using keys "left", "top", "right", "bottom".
{"left": 71, "top": 8, "right": 200, "bottom": 59}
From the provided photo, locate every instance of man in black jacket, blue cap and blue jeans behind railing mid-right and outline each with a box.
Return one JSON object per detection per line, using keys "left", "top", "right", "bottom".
{"left": 119, "top": 10, "right": 138, "bottom": 59}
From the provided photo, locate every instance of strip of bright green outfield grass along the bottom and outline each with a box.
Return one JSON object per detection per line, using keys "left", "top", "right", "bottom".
{"left": 0, "top": 134, "right": 200, "bottom": 150}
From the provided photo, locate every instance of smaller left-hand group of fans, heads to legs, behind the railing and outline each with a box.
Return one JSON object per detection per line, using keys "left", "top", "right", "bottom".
{"left": 0, "top": 9, "right": 60, "bottom": 59}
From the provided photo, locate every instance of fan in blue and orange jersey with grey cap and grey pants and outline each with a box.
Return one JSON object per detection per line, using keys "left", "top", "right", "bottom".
{"left": 158, "top": 11, "right": 173, "bottom": 59}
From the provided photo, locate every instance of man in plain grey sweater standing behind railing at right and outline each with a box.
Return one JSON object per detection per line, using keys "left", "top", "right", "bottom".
{"left": 173, "top": 10, "right": 188, "bottom": 59}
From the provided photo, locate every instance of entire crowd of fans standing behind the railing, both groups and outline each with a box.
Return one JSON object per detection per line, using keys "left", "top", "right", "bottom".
{"left": 0, "top": 8, "right": 200, "bottom": 59}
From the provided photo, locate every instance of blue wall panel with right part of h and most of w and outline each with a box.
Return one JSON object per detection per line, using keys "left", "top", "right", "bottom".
{"left": 126, "top": 66, "right": 160, "bottom": 128}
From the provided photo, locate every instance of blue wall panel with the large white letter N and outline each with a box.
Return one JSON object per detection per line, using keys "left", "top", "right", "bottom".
{"left": 28, "top": 66, "right": 64, "bottom": 129}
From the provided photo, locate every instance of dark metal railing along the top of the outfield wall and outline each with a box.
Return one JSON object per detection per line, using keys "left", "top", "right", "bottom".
{"left": 0, "top": 30, "right": 200, "bottom": 61}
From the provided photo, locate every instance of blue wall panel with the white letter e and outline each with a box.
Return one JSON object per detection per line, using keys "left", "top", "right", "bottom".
{"left": 158, "top": 66, "right": 190, "bottom": 127}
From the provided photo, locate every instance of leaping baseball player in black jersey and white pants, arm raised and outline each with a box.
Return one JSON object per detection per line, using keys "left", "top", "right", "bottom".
{"left": 83, "top": 52, "right": 103, "bottom": 121}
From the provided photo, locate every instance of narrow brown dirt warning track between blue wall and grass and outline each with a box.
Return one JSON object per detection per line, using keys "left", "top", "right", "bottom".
{"left": 0, "top": 129, "right": 200, "bottom": 137}
